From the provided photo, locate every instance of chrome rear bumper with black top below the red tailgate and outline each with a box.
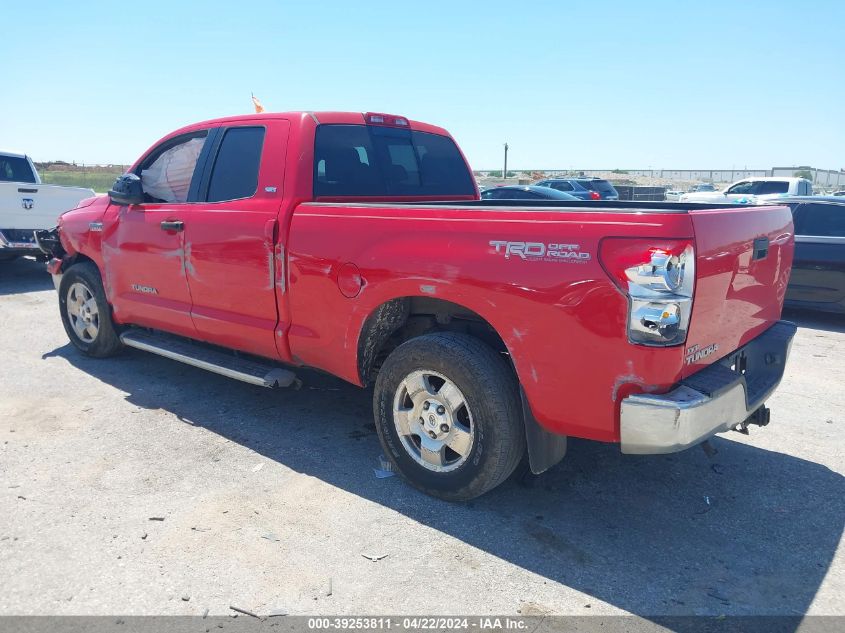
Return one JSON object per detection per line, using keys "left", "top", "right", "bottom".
{"left": 620, "top": 321, "right": 797, "bottom": 455}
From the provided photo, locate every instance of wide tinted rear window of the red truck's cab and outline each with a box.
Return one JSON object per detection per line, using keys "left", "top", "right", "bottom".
{"left": 314, "top": 125, "right": 475, "bottom": 197}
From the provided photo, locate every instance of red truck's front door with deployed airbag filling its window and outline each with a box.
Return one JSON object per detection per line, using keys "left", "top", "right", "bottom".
{"left": 102, "top": 130, "right": 209, "bottom": 336}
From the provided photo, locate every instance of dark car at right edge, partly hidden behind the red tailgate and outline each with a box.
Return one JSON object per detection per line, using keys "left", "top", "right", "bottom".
{"left": 777, "top": 196, "right": 845, "bottom": 313}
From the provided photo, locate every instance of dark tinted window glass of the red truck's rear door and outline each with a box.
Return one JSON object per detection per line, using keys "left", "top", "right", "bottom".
{"left": 206, "top": 127, "right": 264, "bottom": 202}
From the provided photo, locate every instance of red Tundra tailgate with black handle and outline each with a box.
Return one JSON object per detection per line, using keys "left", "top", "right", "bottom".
{"left": 683, "top": 206, "right": 793, "bottom": 377}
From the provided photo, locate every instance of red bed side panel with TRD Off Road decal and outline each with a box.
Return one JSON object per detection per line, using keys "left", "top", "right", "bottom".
{"left": 289, "top": 203, "right": 692, "bottom": 441}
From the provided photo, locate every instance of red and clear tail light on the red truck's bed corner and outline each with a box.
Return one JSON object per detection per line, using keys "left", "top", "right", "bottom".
{"left": 599, "top": 238, "right": 695, "bottom": 346}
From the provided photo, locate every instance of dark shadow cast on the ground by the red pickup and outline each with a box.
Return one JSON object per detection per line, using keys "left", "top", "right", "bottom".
{"left": 45, "top": 345, "right": 845, "bottom": 629}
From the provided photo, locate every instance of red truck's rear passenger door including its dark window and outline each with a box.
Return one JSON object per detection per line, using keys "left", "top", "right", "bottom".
{"left": 180, "top": 119, "right": 289, "bottom": 358}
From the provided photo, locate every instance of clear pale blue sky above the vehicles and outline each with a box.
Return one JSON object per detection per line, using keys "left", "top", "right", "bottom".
{"left": 0, "top": 0, "right": 845, "bottom": 169}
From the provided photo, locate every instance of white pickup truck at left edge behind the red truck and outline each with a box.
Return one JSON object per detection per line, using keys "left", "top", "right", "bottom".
{"left": 0, "top": 151, "right": 94, "bottom": 262}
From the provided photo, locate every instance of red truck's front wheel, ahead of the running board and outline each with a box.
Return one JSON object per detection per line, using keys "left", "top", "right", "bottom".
{"left": 59, "top": 262, "right": 123, "bottom": 358}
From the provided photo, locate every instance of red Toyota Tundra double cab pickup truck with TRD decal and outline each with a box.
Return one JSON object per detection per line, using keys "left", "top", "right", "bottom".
{"left": 38, "top": 112, "right": 795, "bottom": 500}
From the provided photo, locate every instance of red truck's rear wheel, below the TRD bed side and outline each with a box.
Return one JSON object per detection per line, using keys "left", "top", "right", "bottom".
{"left": 373, "top": 332, "right": 525, "bottom": 501}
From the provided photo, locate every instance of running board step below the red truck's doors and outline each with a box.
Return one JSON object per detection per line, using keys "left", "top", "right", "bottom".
{"left": 120, "top": 329, "right": 302, "bottom": 389}
